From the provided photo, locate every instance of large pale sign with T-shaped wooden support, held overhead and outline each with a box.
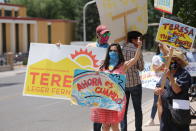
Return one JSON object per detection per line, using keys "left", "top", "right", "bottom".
{"left": 95, "top": 0, "right": 148, "bottom": 42}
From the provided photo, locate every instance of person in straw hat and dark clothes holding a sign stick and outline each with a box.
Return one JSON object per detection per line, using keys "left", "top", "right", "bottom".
{"left": 154, "top": 50, "right": 191, "bottom": 131}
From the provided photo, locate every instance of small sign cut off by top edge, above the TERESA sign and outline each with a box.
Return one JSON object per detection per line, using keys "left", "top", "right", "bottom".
{"left": 154, "top": 0, "right": 174, "bottom": 14}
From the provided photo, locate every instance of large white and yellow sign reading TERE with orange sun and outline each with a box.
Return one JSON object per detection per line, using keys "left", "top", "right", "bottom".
{"left": 23, "top": 44, "right": 106, "bottom": 99}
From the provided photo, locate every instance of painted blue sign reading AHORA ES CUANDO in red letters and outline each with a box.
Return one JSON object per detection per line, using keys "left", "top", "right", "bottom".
{"left": 71, "top": 69, "right": 126, "bottom": 111}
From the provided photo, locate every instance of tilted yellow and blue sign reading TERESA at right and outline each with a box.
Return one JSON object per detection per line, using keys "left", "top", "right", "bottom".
{"left": 156, "top": 17, "right": 196, "bottom": 51}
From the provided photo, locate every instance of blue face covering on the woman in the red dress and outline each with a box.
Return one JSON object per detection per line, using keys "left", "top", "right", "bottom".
{"left": 109, "top": 51, "right": 119, "bottom": 70}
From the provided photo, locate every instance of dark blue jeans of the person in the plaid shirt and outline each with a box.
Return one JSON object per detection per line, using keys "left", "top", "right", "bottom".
{"left": 120, "top": 84, "right": 143, "bottom": 131}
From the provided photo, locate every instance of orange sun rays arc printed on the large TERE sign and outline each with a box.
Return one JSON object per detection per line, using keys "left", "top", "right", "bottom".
{"left": 71, "top": 49, "right": 99, "bottom": 68}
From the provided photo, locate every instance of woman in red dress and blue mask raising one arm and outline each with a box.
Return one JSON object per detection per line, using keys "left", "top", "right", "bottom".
{"left": 91, "top": 42, "right": 142, "bottom": 131}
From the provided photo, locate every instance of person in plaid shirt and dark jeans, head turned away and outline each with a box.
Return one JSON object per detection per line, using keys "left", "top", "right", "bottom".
{"left": 121, "top": 31, "right": 144, "bottom": 131}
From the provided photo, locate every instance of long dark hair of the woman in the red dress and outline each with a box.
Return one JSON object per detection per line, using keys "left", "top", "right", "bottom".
{"left": 100, "top": 43, "right": 125, "bottom": 70}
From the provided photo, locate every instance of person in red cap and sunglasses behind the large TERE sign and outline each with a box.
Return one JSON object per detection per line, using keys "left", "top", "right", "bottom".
{"left": 87, "top": 25, "right": 111, "bottom": 48}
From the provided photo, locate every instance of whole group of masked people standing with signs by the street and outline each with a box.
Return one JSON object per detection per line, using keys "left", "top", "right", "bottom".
{"left": 87, "top": 25, "right": 191, "bottom": 131}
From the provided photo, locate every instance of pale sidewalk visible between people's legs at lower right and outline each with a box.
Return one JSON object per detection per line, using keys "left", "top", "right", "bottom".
{"left": 128, "top": 99, "right": 196, "bottom": 131}
